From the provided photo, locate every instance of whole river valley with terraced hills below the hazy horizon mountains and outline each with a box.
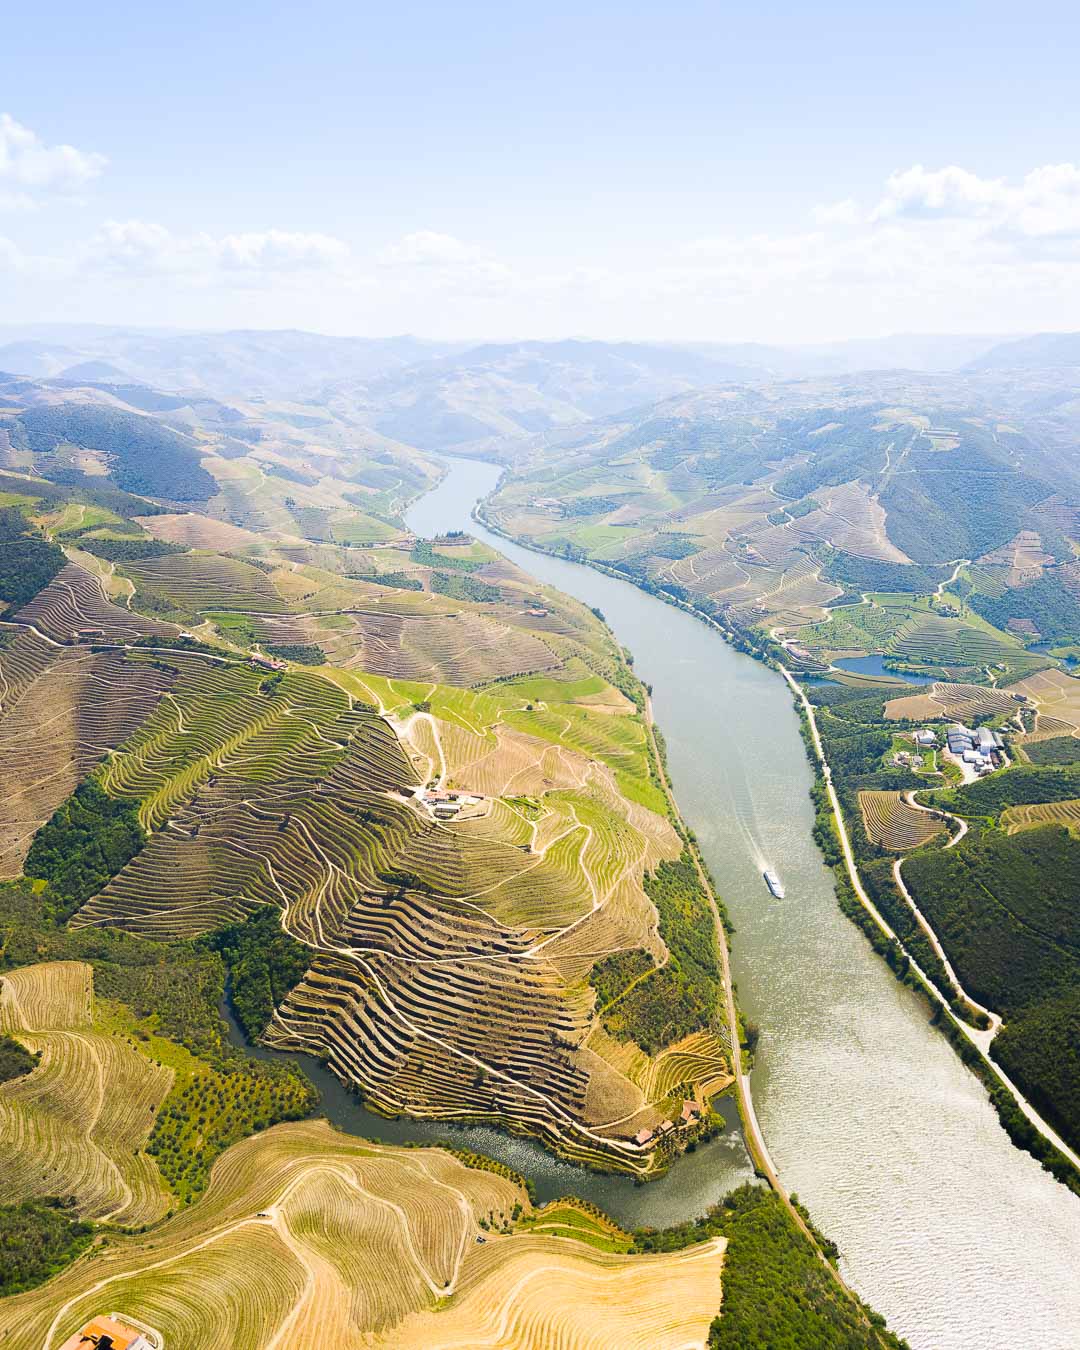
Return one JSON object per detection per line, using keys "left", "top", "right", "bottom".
{"left": 0, "top": 329, "right": 1080, "bottom": 1350}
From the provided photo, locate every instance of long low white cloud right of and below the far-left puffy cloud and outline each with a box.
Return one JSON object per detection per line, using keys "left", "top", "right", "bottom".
{"left": 85, "top": 220, "right": 350, "bottom": 282}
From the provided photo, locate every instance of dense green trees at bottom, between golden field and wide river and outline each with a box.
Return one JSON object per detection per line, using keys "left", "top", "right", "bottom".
{"left": 633, "top": 1183, "right": 903, "bottom": 1350}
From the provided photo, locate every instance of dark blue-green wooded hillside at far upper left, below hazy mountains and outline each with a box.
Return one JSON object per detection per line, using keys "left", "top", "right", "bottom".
{"left": 12, "top": 404, "right": 217, "bottom": 501}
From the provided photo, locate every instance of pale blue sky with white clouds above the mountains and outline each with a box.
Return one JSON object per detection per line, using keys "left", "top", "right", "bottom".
{"left": 0, "top": 0, "right": 1080, "bottom": 343}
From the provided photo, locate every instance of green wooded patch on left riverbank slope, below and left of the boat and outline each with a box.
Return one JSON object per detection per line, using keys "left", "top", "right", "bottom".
{"left": 590, "top": 851, "right": 721, "bottom": 1054}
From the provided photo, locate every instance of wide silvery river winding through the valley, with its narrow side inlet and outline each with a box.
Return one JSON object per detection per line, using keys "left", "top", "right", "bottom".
{"left": 409, "top": 460, "right": 1080, "bottom": 1350}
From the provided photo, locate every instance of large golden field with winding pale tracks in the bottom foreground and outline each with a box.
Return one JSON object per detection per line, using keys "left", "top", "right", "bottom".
{"left": 0, "top": 1122, "right": 725, "bottom": 1350}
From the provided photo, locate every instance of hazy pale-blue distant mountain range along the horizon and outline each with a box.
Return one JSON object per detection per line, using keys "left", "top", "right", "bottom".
{"left": 0, "top": 325, "right": 1080, "bottom": 458}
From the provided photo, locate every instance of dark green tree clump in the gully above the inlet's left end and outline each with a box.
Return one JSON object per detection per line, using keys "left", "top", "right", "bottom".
{"left": 203, "top": 905, "right": 311, "bottom": 1041}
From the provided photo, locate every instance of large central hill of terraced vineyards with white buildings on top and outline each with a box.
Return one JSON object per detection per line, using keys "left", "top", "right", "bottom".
{"left": 74, "top": 631, "right": 707, "bottom": 1170}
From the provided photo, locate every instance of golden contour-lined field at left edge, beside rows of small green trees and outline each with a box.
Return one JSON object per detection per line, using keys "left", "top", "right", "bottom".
{"left": 0, "top": 961, "right": 173, "bottom": 1226}
